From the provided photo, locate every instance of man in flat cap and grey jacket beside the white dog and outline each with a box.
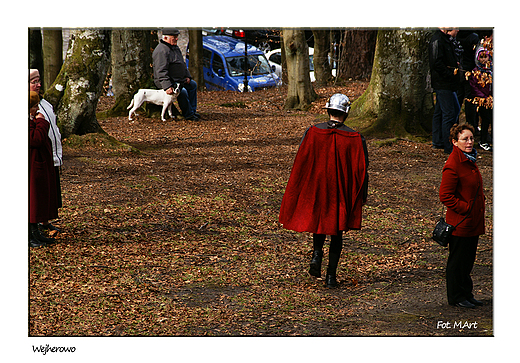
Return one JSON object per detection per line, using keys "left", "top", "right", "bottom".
{"left": 152, "top": 28, "right": 200, "bottom": 121}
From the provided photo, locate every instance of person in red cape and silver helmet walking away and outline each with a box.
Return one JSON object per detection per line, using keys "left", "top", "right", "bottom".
{"left": 279, "top": 93, "right": 368, "bottom": 287}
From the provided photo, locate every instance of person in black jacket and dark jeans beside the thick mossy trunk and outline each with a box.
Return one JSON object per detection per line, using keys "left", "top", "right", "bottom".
{"left": 429, "top": 28, "right": 461, "bottom": 154}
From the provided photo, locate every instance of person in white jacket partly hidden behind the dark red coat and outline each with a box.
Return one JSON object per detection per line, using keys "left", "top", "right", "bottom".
{"left": 29, "top": 69, "right": 63, "bottom": 232}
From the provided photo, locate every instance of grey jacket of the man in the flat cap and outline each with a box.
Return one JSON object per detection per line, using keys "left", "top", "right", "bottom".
{"left": 152, "top": 40, "right": 192, "bottom": 90}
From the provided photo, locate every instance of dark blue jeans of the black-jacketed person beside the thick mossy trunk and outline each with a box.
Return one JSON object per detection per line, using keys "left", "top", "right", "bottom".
{"left": 432, "top": 89, "right": 460, "bottom": 153}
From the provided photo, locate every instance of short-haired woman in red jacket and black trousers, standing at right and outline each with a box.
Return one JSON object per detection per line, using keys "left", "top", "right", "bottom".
{"left": 439, "top": 124, "right": 485, "bottom": 308}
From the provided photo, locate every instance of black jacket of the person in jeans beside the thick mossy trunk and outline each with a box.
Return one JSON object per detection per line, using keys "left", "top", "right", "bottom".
{"left": 429, "top": 30, "right": 461, "bottom": 91}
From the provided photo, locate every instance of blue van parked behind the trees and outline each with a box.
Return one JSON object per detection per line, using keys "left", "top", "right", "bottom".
{"left": 187, "top": 35, "right": 281, "bottom": 92}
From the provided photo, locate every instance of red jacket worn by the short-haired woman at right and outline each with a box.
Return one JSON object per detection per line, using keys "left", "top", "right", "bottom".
{"left": 439, "top": 146, "right": 486, "bottom": 237}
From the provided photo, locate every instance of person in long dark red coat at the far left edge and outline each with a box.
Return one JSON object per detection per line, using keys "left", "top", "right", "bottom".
{"left": 29, "top": 92, "right": 58, "bottom": 247}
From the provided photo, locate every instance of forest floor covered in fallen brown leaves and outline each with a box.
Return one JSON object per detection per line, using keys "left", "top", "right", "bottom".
{"left": 28, "top": 82, "right": 494, "bottom": 337}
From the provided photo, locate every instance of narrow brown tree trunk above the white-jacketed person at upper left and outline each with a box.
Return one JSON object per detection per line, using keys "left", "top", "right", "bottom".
{"left": 42, "top": 28, "right": 63, "bottom": 90}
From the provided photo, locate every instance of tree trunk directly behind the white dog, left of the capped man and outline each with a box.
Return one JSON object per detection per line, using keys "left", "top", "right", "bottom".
{"left": 106, "top": 28, "right": 155, "bottom": 116}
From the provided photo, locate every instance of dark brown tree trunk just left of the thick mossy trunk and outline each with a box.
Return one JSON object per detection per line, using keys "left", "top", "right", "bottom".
{"left": 338, "top": 29, "right": 377, "bottom": 80}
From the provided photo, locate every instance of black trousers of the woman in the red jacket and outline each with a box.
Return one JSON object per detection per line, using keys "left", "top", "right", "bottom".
{"left": 446, "top": 236, "right": 478, "bottom": 305}
